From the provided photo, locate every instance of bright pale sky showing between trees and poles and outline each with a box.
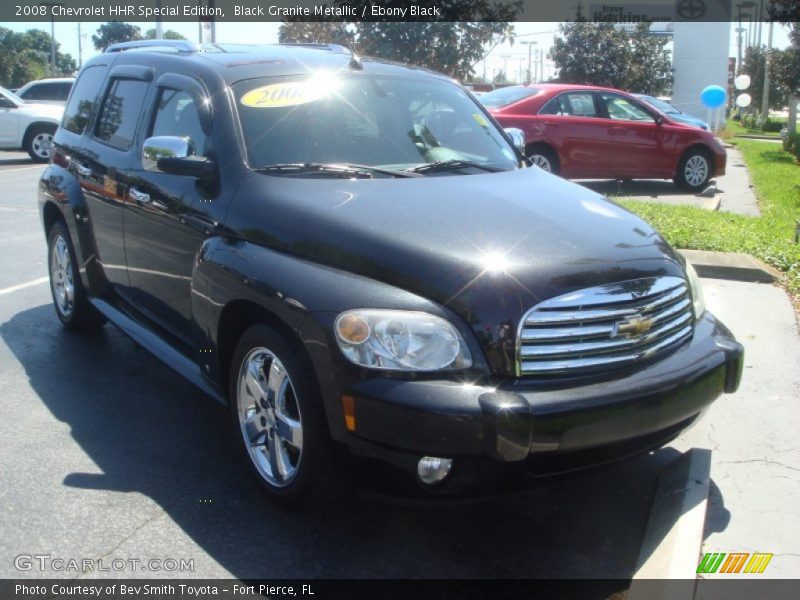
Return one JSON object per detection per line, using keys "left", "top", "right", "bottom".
{"left": 0, "top": 21, "right": 789, "bottom": 81}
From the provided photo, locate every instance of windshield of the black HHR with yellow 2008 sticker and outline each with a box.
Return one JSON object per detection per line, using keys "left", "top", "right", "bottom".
{"left": 232, "top": 72, "right": 518, "bottom": 176}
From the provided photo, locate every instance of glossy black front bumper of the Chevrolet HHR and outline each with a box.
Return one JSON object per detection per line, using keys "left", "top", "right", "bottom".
{"left": 348, "top": 313, "right": 743, "bottom": 490}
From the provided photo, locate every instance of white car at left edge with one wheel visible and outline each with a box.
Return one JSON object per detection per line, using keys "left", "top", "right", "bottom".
{"left": 0, "top": 87, "right": 64, "bottom": 162}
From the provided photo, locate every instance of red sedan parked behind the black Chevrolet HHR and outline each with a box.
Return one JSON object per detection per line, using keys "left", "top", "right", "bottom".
{"left": 481, "top": 84, "right": 726, "bottom": 191}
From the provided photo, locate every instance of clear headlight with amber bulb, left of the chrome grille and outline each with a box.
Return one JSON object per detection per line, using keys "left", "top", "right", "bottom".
{"left": 334, "top": 309, "right": 472, "bottom": 371}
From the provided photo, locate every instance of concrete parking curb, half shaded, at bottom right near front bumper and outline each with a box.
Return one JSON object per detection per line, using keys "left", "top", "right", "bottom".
{"left": 627, "top": 448, "right": 711, "bottom": 600}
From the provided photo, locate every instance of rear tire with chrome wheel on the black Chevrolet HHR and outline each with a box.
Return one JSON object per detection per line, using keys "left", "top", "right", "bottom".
{"left": 47, "top": 221, "right": 106, "bottom": 331}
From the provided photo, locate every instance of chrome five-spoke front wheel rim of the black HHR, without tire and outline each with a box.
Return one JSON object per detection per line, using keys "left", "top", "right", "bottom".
{"left": 236, "top": 348, "right": 303, "bottom": 488}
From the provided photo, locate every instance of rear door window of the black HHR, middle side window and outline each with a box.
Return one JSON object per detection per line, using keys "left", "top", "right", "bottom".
{"left": 95, "top": 79, "right": 147, "bottom": 150}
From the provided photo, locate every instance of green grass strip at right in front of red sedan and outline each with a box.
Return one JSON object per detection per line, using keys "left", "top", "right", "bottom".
{"left": 619, "top": 139, "right": 800, "bottom": 294}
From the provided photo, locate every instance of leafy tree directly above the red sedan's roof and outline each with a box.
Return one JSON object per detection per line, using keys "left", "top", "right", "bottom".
{"left": 550, "top": 21, "right": 672, "bottom": 95}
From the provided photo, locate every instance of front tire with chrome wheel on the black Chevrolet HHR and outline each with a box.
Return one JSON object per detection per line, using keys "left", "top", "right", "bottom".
{"left": 228, "top": 325, "right": 343, "bottom": 506}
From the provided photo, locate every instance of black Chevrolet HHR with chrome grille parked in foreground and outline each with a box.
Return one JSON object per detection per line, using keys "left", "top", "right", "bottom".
{"left": 39, "top": 41, "right": 742, "bottom": 502}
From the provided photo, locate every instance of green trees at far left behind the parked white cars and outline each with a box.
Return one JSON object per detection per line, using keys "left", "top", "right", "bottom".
{"left": 0, "top": 27, "right": 76, "bottom": 88}
